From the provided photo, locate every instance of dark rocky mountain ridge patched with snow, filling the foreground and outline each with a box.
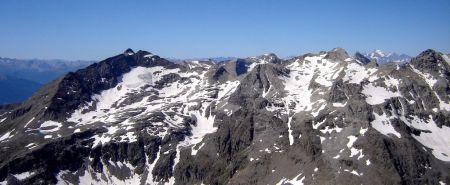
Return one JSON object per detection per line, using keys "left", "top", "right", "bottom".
{"left": 0, "top": 48, "right": 450, "bottom": 184}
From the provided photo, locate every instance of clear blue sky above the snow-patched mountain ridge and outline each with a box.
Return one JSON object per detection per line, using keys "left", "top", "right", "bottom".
{"left": 0, "top": 0, "right": 450, "bottom": 60}
